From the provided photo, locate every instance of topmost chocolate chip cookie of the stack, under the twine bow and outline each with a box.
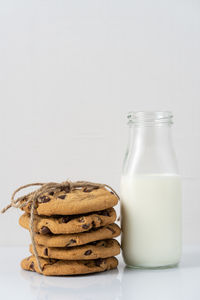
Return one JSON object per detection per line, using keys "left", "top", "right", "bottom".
{"left": 23, "top": 187, "right": 118, "bottom": 216}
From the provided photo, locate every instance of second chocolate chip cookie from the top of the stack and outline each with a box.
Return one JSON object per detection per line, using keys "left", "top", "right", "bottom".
{"left": 19, "top": 208, "right": 116, "bottom": 234}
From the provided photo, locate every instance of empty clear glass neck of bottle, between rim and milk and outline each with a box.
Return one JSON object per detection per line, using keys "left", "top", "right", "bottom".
{"left": 124, "top": 124, "right": 178, "bottom": 174}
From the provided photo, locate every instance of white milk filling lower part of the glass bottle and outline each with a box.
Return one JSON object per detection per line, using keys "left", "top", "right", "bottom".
{"left": 121, "top": 174, "right": 181, "bottom": 268}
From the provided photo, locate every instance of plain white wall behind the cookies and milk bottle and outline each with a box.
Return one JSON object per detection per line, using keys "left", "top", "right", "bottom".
{"left": 0, "top": 0, "right": 200, "bottom": 245}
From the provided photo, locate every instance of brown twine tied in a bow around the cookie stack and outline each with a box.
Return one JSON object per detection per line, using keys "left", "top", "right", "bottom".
{"left": 1, "top": 181, "right": 119, "bottom": 273}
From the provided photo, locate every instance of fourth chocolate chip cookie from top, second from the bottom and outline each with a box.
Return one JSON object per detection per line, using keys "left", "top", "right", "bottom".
{"left": 30, "top": 240, "right": 120, "bottom": 260}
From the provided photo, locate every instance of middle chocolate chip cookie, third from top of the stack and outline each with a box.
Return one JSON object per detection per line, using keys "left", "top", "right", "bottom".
{"left": 35, "top": 224, "right": 120, "bottom": 247}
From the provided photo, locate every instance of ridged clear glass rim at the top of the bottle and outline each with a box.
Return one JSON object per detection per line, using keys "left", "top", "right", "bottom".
{"left": 127, "top": 111, "right": 173, "bottom": 126}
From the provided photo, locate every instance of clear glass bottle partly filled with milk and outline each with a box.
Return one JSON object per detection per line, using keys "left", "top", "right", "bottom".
{"left": 120, "top": 112, "right": 181, "bottom": 268}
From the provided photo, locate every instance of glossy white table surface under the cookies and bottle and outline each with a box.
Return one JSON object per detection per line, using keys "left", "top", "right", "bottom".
{"left": 0, "top": 247, "right": 200, "bottom": 300}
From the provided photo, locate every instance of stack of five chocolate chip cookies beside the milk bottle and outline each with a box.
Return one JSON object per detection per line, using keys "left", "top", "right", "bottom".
{"left": 19, "top": 187, "right": 120, "bottom": 275}
